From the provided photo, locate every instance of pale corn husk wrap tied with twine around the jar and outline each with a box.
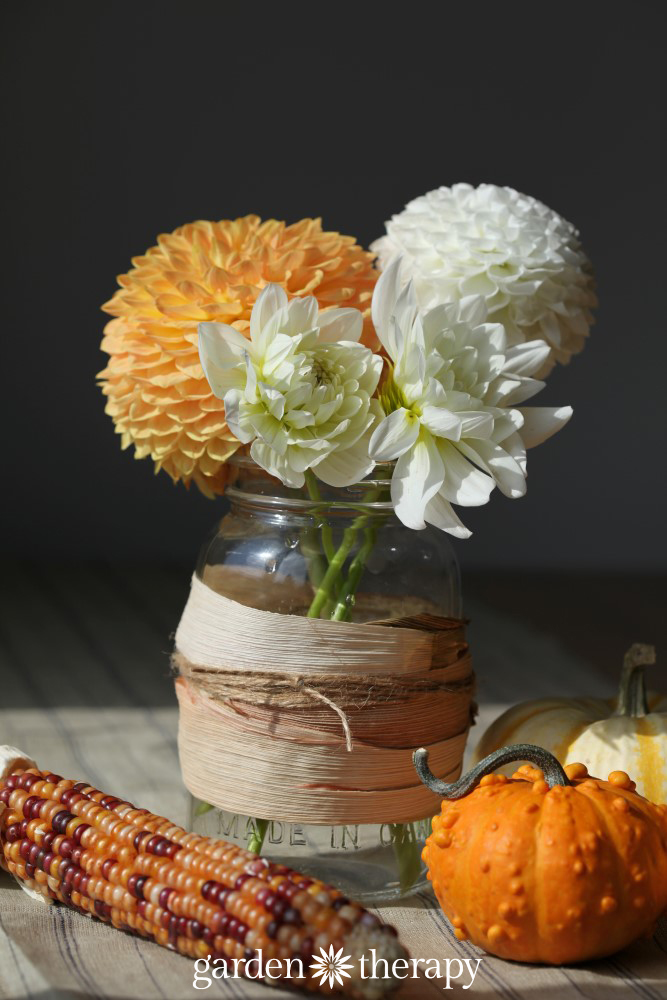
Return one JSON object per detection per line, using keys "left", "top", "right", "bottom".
{"left": 173, "top": 576, "right": 474, "bottom": 824}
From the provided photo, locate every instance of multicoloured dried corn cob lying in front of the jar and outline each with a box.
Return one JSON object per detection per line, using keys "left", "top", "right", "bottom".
{"left": 0, "top": 752, "right": 406, "bottom": 1000}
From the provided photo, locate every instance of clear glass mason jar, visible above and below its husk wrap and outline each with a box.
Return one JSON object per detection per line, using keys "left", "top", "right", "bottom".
{"left": 185, "top": 456, "right": 462, "bottom": 903}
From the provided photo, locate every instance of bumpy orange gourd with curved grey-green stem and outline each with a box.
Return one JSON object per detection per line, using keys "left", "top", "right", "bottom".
{"left": 414, "top": 744, "right": 667, "bottom": 965}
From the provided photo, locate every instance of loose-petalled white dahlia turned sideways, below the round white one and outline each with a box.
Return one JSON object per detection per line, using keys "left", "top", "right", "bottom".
{"left": 369, "top": 258, "right": 572, "bottom": 538}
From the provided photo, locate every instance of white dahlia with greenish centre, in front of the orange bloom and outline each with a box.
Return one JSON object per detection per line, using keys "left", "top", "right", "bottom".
{"left": 199, "top": 285, "right": 382, "bottom": 488}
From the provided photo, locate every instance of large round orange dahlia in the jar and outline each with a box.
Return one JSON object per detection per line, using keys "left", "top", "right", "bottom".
{"left": 98, "top": 215, "right": 377, "bottom": 496}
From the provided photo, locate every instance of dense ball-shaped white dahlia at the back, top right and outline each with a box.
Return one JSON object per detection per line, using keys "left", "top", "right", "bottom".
{"left": 371, "top": 184, "right": 597, "bottom": 374}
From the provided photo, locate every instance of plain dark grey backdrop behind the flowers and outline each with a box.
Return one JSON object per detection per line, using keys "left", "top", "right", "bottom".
{"left": 2, "top": 2, "right": 667, "bottom": 570}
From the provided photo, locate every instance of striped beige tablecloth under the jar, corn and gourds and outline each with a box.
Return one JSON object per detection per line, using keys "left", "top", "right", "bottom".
{"left": 0, "top": 571, "right": 667, "bottom": 1000}
